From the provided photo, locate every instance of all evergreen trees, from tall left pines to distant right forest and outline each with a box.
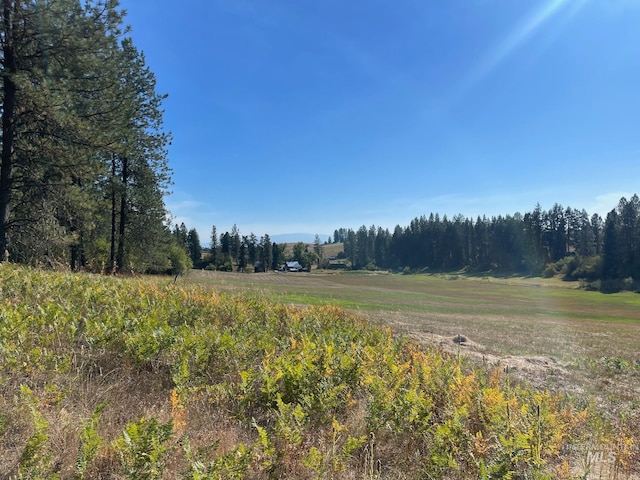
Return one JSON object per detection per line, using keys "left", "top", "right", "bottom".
{"left": 0, "top": 0, "right": 640, "bottom": 280}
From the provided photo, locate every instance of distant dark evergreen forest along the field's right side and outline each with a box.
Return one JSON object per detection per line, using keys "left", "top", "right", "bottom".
{"left": 333, "top": 195, "right": 640, "bottom": 288}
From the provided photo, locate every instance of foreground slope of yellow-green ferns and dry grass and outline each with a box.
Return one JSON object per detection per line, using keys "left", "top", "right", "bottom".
{"left": 0, "top": 265, "right": 636, "bottom": 480}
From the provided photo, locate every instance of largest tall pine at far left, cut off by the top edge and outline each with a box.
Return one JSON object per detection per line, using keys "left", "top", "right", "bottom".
{"left": 0, "top": 0, "right": 122, "bottom": 261}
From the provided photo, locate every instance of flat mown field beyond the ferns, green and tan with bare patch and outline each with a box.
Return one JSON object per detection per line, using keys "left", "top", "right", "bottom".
{"left": 184, "top": 271, "right": 640, "bottom": 413}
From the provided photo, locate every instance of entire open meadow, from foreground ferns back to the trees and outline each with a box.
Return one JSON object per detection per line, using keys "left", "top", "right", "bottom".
{"left": 0, "top": 264, "right": 640, "bottom": 480}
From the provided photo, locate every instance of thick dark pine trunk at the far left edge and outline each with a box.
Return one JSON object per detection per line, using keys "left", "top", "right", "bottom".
{"left": 0, "top": 0, "right": 18, "bottom": 261}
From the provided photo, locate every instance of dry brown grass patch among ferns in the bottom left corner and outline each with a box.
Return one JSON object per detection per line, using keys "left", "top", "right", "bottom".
{"left": 0, "top": 355, "right": 170, "bottom": 479}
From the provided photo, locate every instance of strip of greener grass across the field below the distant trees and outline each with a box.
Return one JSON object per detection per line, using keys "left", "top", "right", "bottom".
{"left": 186, "top": 272, "right": 640, "bottom": 324}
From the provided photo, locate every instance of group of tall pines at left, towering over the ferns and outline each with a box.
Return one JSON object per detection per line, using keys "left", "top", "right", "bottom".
{"left": 0, "top": 0, "right": 183, "bottom": 272}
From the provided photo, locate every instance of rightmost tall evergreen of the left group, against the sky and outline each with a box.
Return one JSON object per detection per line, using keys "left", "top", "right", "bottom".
{"left": 110, "top": 39, "right": 171, "bottom": 267}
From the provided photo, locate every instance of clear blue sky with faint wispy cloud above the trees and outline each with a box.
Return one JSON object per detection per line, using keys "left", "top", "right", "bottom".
{"left": 121, "top": 0, "right": 640, "bottom": 240}
